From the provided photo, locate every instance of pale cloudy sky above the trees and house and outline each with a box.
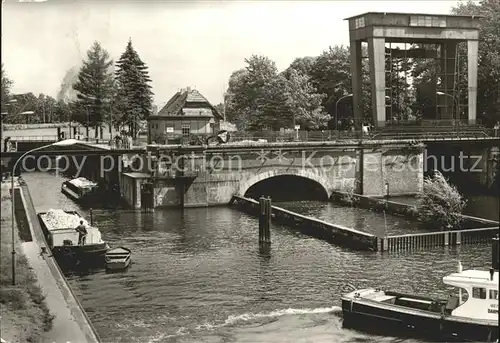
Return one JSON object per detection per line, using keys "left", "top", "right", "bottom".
{"left": 1, "top": 0, "right": 468, "bottom": 105}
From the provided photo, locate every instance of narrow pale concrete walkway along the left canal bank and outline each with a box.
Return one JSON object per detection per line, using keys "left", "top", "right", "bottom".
{"left": 21, "top": 185, "right": 100, "bottom": 343}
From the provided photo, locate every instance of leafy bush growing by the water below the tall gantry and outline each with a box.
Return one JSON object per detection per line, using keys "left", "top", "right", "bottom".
{"left": 417, "top": 172, "right": 466, "bottom": 230}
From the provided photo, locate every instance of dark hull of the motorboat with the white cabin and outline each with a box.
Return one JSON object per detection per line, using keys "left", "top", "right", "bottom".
{"left": 342, "top": 299, "right": 498, "bottom": 342}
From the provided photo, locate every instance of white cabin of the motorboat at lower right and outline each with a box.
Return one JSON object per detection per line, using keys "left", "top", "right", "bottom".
{"left": 443, "top": 269, "right": 498, "bottom": 320}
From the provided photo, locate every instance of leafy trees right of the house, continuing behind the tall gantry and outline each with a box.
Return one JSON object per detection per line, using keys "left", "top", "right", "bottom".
{"left": 224, "top": 0, "right": 500, "bottom": 130}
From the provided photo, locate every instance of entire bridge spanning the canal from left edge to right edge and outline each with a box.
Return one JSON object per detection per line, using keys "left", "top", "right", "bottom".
{"left": 2, "top": 138, "right": 499, "bottom": 208}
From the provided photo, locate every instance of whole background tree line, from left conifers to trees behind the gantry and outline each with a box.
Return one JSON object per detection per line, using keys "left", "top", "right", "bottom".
{"left": 2, "top": 0, "right": 500, "bottom": 135}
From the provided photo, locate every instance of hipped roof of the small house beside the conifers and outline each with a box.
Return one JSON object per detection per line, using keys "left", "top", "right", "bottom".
{"left": 151, "top": 88, "right": 222, "bottom": 119}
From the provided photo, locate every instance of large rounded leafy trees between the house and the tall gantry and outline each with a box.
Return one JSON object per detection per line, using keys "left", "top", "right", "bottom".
{"left": 226, "top": 55, "right": 328, "bottom": 130}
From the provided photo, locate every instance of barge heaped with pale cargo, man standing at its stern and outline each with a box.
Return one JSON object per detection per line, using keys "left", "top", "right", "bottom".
{"left": 37, "top": 209, "right": 109, "bottom": 265}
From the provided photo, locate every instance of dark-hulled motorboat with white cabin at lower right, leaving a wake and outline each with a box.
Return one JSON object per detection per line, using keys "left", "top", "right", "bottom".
{"left": 341, "top": 236, "right": 499, "bottom": 342}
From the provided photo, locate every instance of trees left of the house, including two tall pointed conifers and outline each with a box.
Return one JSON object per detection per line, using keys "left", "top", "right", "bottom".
{"left": 2, "top": 40, "right": 153, "bottom": 137}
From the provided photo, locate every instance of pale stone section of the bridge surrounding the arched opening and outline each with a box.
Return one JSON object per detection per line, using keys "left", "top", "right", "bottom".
{"left": 125, "top": 142, "right": 423, "bottom": 208}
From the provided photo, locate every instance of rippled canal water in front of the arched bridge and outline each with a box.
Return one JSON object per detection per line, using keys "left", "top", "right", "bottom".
{"left": 23, "top": 173, "right": 491, "bottom": 343}
